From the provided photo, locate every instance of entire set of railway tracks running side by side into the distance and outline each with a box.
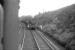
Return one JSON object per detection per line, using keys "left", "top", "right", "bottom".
{"left": 20, "top": 30, "right": 64, "bottom": 50}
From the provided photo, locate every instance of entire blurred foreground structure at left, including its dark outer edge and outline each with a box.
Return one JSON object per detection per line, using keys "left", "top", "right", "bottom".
{"left": 0, "top": 0, "right": 19, "bottom": 50}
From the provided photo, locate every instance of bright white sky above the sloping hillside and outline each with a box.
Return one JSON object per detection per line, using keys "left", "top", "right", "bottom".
{"left": 19, "top": 0, "right": 75, "bottom": 17}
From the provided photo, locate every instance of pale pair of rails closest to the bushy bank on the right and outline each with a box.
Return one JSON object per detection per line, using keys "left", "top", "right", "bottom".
{"left": 33, "top": 31, "right": 65, "bottom": 50}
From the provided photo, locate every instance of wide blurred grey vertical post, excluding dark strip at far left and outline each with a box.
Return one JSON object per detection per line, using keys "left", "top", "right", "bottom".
{"left": 3, "top": 0, "right": 19, "bottom": 50}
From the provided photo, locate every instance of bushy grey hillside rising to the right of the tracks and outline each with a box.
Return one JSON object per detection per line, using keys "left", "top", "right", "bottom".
{"left": 19, "top": 4, "right": 75, "bottom": 48}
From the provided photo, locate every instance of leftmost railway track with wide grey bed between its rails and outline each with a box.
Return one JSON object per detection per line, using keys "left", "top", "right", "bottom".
{"left": 18, "top": 30, "right": 39, "bottom": 50}
